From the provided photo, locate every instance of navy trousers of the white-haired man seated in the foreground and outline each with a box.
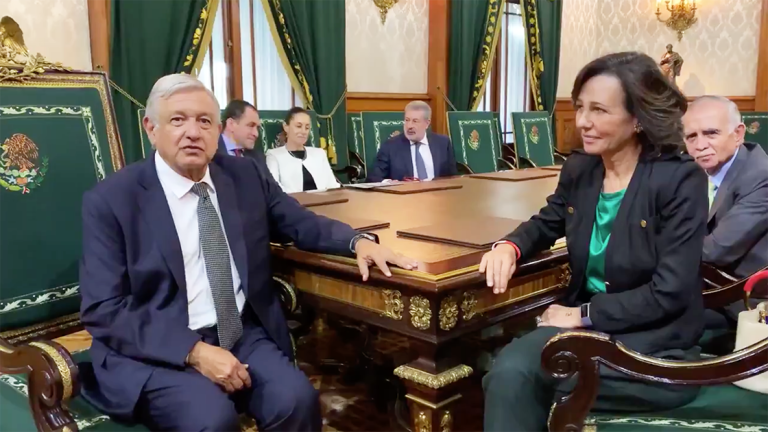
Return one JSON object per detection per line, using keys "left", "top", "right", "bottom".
{"left": 136, "top": 307, "right": 322, "bottom": 432}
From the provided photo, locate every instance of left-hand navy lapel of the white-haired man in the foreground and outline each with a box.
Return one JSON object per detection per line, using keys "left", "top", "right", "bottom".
{"left": 139, "top": 157, "right": 187, "bottom": 291}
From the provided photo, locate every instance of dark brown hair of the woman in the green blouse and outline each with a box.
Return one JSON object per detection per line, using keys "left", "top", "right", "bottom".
{"left": 571, "top": 52, "right": 688, "bottom": 155}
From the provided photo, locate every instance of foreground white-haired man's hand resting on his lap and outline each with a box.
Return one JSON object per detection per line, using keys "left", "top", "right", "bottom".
{"left": 187, "top": 342, "right": 251, "bottom": 394}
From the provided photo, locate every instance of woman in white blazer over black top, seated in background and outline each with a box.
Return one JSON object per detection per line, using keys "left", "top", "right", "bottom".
{"left": 267, "top": 107, "right": 341, "bottom": 193}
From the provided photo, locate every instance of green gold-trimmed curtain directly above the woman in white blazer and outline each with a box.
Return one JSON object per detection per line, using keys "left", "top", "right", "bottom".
{"left": 262, "top": 0, "right": 348, "bottom": 167}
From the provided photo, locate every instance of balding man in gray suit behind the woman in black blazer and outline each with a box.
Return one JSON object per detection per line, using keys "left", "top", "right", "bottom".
{"left": 683, "top": 96, "right": 768, "bottom": 328}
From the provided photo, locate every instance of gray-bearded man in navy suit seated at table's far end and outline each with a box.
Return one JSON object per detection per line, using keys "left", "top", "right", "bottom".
{"left": 368, "top": 101, "right": 458, "bottom": 182}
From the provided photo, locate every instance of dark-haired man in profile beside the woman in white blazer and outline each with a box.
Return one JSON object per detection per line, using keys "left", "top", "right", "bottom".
{"left": 219, "top": 99, "right": 261, "bottom": 157}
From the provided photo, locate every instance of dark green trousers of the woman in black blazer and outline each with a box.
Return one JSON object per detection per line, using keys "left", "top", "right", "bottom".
{"left": 483, "top": 327, "right": 699, "bottom": 432}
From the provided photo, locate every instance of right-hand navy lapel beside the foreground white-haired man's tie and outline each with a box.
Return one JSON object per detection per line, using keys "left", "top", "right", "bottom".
{"left": 209, "top": 163, "right": 248, "bottom": 293}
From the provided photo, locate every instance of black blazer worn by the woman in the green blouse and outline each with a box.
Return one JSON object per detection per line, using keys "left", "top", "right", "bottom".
{"left": 506, "top": 152, "right": 708, "bottom": 354}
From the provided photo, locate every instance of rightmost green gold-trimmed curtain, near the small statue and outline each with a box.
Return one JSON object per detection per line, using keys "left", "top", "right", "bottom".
{"left": 520, "top": 0, "right": 563, "bottom": 114}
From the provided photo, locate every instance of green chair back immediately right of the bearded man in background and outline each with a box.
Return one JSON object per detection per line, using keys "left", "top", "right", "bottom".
{"left": 448, "top": 111, "right": 501, "bottom": 174}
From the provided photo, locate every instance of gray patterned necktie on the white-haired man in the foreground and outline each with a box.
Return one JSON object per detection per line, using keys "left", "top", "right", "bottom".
{"left": 192, "top": 183, "right": 243, "bottom": 350}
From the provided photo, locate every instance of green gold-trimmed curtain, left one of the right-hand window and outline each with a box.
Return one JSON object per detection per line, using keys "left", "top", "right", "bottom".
{"left": 448, "top": 0, "right": 505, "bottom": 111}
